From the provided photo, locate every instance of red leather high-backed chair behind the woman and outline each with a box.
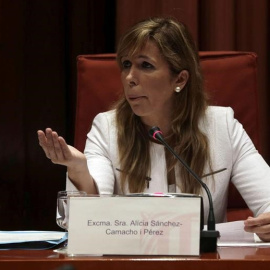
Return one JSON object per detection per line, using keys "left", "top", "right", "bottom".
{"left": 74, "top": 52, "right": 260, "bottom": 221}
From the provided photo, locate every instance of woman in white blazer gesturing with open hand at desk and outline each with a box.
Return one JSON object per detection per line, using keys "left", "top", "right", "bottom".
{"left": 38, "top": 18, "right": 270, "bottom": 241}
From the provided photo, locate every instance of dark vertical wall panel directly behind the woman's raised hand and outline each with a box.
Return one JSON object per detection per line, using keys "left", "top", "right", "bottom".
{"left": 23, "top": 0, "right": 68, "bottom": 230}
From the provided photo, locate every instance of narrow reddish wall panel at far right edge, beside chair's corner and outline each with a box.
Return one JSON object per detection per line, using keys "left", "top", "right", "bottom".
{"left": 235, "top": 0, "right": 270, "bottom": 165}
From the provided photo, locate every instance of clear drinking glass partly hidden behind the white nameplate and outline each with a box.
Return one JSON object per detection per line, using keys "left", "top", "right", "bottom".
{"left": 55, "top": 190, "right": 87, "bottom": 253}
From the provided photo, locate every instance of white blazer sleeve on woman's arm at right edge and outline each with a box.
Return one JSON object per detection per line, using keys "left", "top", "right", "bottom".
{"left": 227, "top": 109, "right": 270, "bottom": 216}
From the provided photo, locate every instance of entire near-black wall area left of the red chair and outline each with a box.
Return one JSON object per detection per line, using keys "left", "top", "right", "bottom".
{"left": 0, "top": 0, "right": 115, "bottom": 230}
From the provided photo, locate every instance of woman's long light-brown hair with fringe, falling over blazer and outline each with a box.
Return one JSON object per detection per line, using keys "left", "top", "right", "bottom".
{"left": 113, "top": 18, "right": 211, "bottom": 193}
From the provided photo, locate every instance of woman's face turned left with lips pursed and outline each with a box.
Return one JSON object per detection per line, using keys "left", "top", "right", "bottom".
{"left": 121, "top": 41, "right": 177, "bottom": 124}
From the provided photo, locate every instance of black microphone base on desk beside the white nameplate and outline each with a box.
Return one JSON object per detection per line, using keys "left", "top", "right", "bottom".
{"left": 200, "top": 230, "right": 220, "bottom": 253}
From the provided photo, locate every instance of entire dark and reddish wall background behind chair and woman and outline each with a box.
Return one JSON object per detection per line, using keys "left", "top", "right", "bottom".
{"left": 0, "top": 0, "right": 270, "bottom": 230}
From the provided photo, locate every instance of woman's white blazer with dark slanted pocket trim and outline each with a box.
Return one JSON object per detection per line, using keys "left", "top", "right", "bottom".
{"left": 67, "top": 106, "right": 270, "bottom": 223}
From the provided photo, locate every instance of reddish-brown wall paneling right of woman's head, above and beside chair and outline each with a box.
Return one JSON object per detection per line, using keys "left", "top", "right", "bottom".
{"left": 199, "top": 0, "right": 270, "bottom": 164}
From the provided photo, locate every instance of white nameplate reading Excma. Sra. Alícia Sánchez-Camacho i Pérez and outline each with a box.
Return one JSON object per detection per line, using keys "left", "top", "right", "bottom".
{"left": 68, "top": 196, "right": 201, "bottom": 256}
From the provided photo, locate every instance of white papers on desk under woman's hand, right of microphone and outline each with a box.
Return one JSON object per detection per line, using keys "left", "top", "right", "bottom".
{"left": 216, "top": 220, "right": 270, "bottom": 247}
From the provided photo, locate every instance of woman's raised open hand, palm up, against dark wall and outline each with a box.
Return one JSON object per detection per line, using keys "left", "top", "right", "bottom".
{"left": 37, "top": 128, "right": 86, "bottom": 169}
